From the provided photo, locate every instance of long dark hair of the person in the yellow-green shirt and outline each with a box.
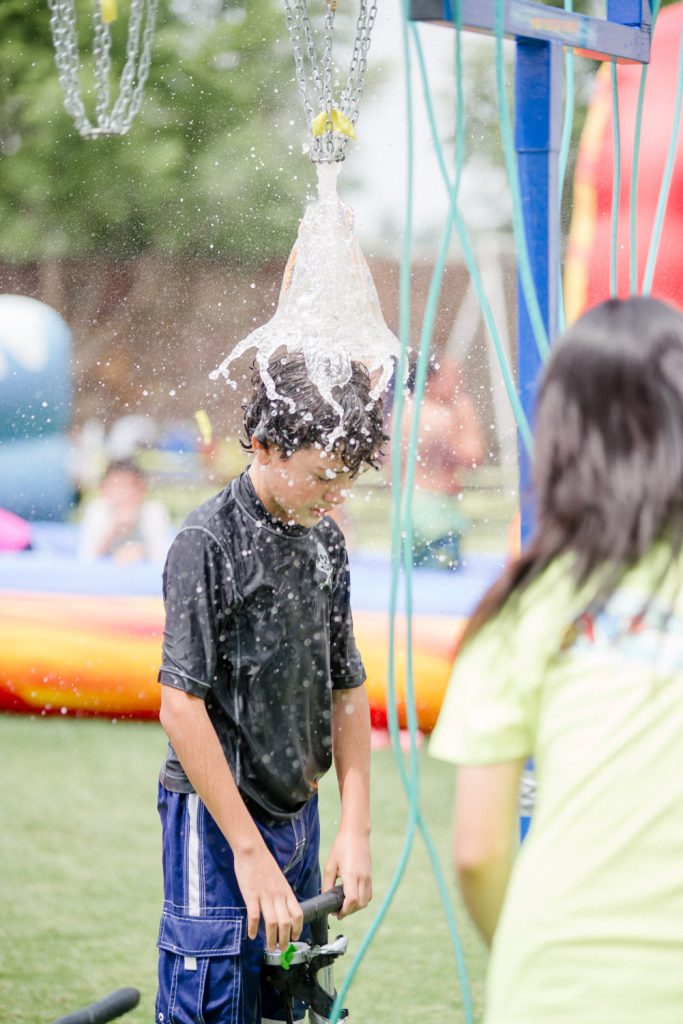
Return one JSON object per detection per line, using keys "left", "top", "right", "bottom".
{"left": 464, "top": 296, "right": 683, "bottom": 639}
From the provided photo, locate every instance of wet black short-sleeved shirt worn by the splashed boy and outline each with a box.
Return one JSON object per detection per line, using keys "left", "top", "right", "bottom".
{"left": 159, "top": 473, "right": 366, "bottom": 819}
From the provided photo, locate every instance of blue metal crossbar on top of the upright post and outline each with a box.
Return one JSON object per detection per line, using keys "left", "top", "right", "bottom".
{"left": 410, "top": 0, "right": 650, "bottom": 63}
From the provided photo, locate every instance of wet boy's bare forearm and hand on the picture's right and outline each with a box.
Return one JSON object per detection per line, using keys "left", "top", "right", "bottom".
{"left": 323, "top": 685, "right": 373, "bottom": 918}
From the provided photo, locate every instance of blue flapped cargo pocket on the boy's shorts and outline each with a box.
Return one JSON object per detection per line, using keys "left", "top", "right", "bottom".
{"left": 156, "top": 911, "right": 243, "bottom": 1024}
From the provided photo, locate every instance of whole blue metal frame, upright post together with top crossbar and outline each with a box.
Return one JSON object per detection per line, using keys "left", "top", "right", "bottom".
{"left": 410, "top": 0, "right": 652, "bottom": 540}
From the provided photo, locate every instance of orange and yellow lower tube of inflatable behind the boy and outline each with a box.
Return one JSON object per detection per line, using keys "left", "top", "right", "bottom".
{"left": 0, "top": 591, "right": 463, "bottom": 732}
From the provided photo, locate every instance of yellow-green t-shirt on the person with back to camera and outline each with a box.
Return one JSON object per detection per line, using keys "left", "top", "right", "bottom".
{"left": 430, "top": 545, "right": 683, "bottom": 1024}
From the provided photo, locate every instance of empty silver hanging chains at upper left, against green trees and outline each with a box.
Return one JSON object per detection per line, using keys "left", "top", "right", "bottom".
{"left": 47, "top": 0, "right": 159, "bottom": 137}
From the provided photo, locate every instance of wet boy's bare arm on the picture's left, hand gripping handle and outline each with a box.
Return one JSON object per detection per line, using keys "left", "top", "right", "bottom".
{"left": 160, "top": 686, "right": 303, "bottom": 949}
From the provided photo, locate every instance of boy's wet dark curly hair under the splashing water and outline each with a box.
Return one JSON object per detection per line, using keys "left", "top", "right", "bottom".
{"left": 241, "top": 352, "right": 388, "bottom": 473}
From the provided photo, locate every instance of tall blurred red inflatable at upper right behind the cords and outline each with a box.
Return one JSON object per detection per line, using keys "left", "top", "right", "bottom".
{"left": 564, "top": 4, "right": 683, "bottom": 322}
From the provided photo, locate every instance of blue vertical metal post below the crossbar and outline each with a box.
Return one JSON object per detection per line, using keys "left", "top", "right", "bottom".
{"left": 515, "top": 39, "right": 562, "bottom": 542}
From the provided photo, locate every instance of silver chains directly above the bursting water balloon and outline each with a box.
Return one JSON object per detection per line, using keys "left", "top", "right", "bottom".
{"left": 284, "top": 0, "right": 377, "bottom": 162}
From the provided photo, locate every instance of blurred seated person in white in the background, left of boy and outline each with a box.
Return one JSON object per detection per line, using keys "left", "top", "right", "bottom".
{"left": 79, "top": 459, "right": 171, "bottom": 565}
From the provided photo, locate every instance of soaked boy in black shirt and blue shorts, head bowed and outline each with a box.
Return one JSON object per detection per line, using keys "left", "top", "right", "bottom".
{"left": 157, "top": 354, "right": 386, "bottom": 1024}
